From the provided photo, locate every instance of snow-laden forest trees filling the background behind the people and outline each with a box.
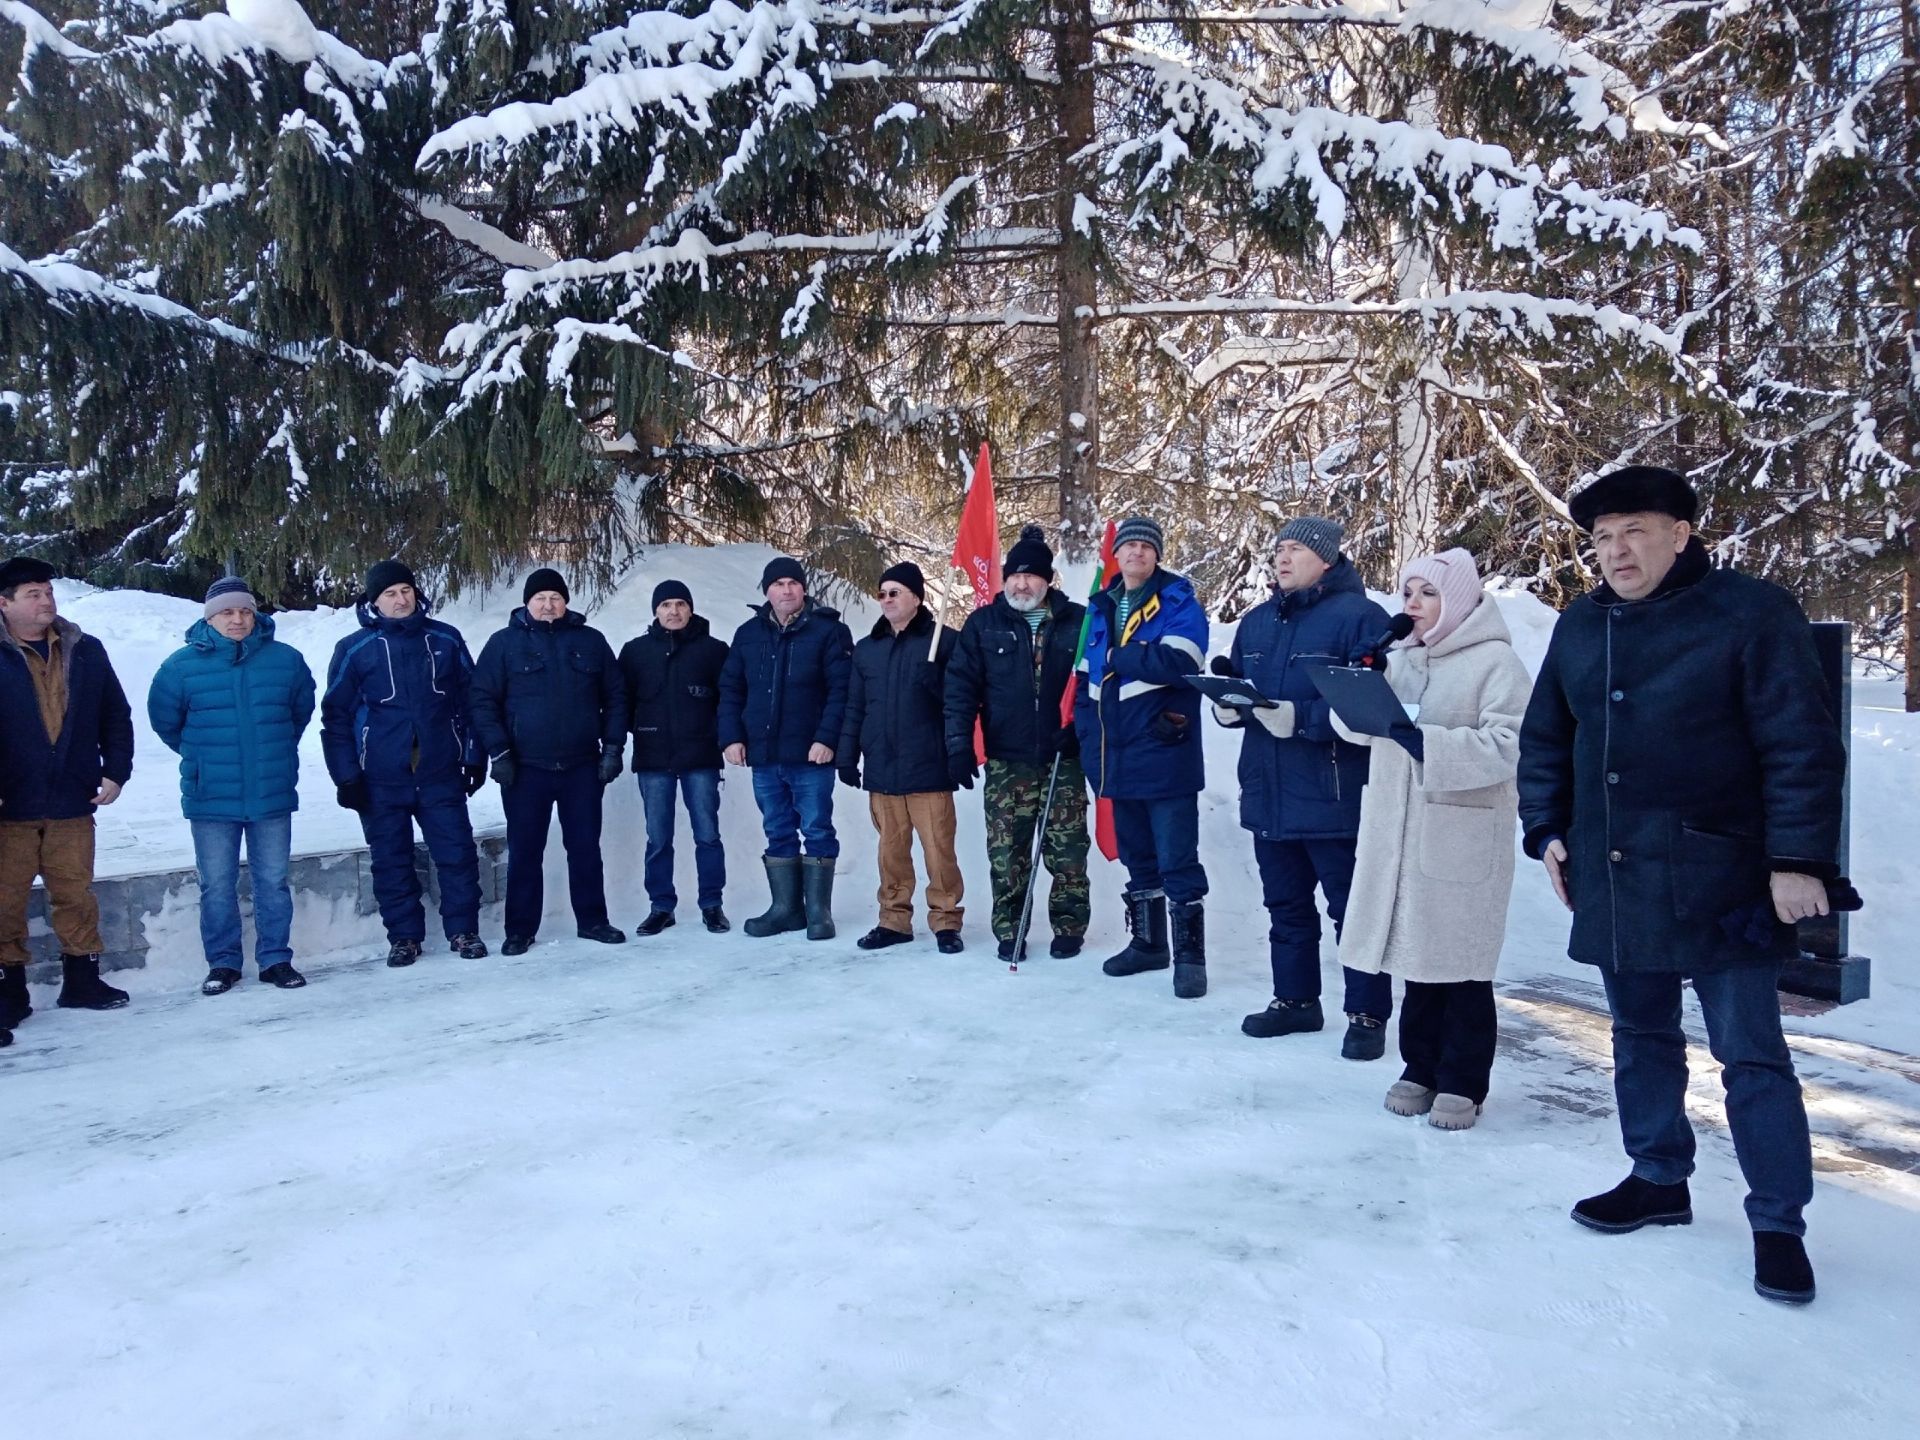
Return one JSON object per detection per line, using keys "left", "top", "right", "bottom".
{"left": 0, "top": 0, "right": 1920, "bottom": 708}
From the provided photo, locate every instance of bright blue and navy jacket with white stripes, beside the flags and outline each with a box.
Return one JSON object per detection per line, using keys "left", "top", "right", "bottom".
{"left": 1073, "top": 568, "right": 1208, "bottom": 801}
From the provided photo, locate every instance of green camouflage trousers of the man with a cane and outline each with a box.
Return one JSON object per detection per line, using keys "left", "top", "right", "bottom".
{"left": 987, "top": 760, "right": 1092, "bottom": 941}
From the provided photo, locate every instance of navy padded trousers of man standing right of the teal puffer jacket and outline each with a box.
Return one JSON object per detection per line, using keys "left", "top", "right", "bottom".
{"left": 361, "top": 770, "right": 480, "bottom": 941}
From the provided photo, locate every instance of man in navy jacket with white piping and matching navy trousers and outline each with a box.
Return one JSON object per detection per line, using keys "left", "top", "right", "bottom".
{"left": 321, "top": 561, "right": 486, "bottom": 966}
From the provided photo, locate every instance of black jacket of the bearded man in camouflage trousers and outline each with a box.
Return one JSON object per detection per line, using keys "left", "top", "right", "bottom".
{"left": 945, "top": 589, "right": 1087, "bottom": 764}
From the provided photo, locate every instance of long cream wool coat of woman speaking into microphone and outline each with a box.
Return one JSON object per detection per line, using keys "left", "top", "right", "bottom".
{"left": 1334, "top": 599, "right": 1532, "bottom": 985}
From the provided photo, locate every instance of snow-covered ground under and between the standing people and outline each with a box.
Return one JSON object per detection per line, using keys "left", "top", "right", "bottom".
{"left": 0, "top": 549, "right": 1920, "bottom": 1440}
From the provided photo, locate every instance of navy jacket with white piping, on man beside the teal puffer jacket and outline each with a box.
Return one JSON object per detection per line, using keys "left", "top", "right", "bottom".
{"left": 321, "top": 599, "right": 482, "bottom": 785}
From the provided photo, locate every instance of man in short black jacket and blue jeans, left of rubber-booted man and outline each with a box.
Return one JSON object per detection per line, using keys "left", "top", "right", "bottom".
{"left": 620, "top": 580, "right": 730, "bottom": 935}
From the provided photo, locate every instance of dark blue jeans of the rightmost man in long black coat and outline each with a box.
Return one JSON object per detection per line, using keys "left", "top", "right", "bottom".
{"left": 1599, "top": 964, "right": 1812, "bottom": 1235}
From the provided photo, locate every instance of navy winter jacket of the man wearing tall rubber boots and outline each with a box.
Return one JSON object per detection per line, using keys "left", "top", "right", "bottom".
{"left": 720, "top": 599, "right": 852, "bottom": 764}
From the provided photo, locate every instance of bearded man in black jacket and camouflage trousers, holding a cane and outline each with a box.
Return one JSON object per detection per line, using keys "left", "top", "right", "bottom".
{"left": 947, "top": 524, "right": 1091, "bottom": 960}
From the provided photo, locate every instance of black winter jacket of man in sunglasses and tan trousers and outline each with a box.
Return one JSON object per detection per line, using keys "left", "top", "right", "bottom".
{"left": 833, "top": 607, "right": 972, "bottom": 795}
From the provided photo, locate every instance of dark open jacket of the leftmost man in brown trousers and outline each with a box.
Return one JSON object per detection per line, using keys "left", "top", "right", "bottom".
{"left": 0, "top": 618, "right": 132, "bottom": 820}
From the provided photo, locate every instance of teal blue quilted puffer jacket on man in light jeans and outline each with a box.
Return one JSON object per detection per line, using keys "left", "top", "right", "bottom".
{"left": 146, "top": 614, "right": 313, "bottom": 820}
